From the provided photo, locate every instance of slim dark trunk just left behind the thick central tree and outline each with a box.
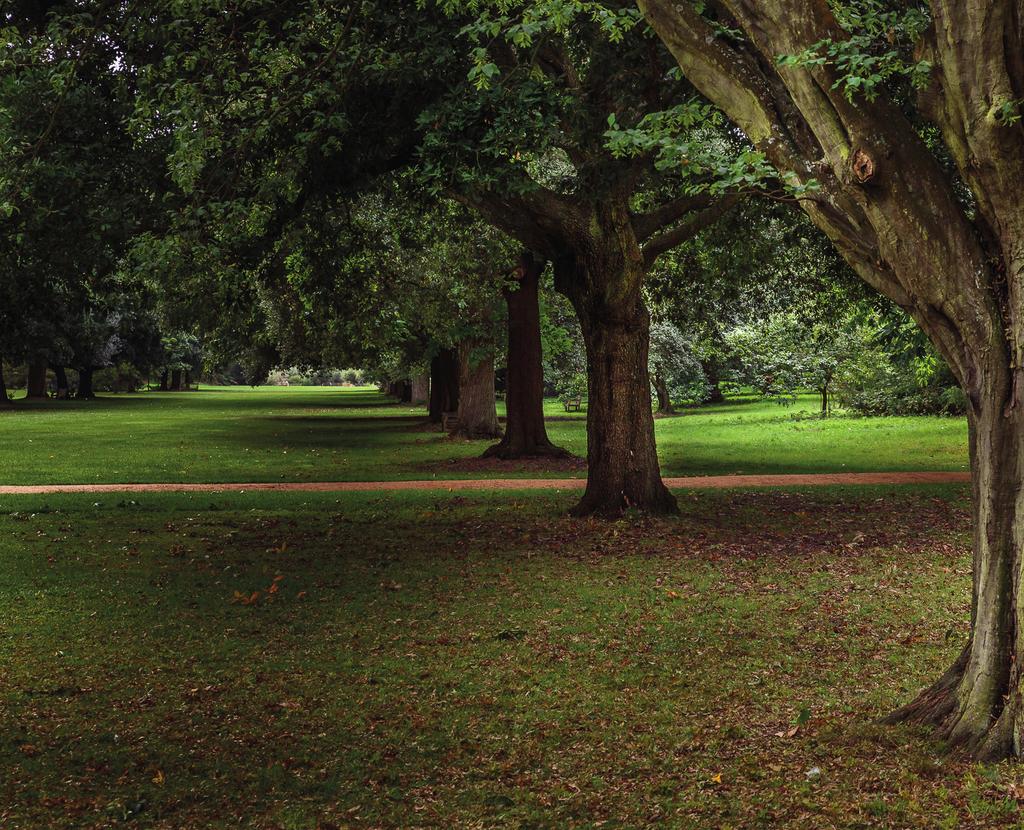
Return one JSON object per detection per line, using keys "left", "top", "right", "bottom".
{"left": 483, "top": 252, "right": 570, "bottom": 460}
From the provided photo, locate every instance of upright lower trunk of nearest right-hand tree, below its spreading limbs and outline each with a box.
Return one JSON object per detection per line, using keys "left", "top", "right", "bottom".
{"left": 888, "top": 382, "right": 1024, "bottom": 758}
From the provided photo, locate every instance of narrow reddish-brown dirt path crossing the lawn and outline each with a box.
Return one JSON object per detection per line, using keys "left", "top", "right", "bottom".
{"left": 0, "top": 472, "right": 971, "bottom": 495}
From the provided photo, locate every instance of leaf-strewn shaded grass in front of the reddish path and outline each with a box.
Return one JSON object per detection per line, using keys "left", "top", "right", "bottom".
{"left": 0, "top": 487, "right": 1024, "bottom": 830}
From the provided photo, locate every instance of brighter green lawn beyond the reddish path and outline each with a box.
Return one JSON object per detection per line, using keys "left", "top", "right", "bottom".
{"left": 0, "top": 387, "right": 967, "bottom": 484}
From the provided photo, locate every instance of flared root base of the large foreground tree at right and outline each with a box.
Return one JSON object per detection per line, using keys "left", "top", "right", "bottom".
{"left": 882, "top": 646, "right": 1024, "bottom": 761}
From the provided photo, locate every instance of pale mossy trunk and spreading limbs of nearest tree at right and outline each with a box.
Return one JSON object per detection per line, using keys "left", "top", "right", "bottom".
{"left": 638, "top": 0, "right": 1024, "bottom": 758}
